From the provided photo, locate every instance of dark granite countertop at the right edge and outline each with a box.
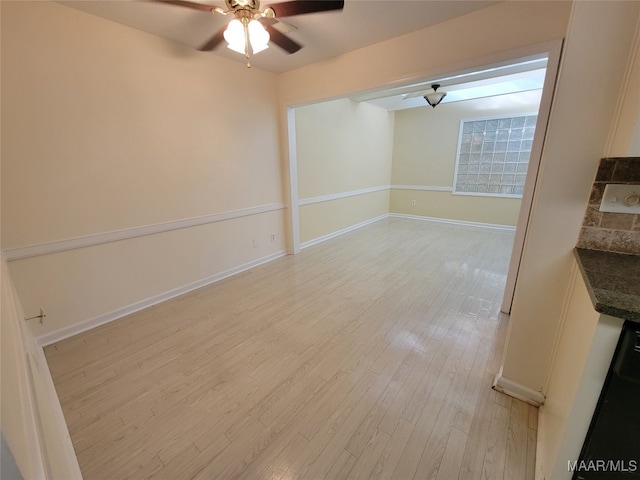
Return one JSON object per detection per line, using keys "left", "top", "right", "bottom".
{"left": 575, "top": 248, "right": 640, "bottom": 323}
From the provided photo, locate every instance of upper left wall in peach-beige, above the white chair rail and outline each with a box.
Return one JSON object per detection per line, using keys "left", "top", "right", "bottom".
{"left": 2, "top": 2, "right": 281, "bottom": 249}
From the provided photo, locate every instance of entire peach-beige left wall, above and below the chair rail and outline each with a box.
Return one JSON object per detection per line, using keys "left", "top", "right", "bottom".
{"left": 2, "top": 2, "right": 285, "bottom": 335}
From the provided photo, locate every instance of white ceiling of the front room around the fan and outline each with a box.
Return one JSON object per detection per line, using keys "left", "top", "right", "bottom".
{"left": 59, "top": 0, "right": 497, "bottom": 73}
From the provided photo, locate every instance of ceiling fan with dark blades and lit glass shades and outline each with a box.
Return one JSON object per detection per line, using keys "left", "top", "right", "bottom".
{"left": 153, "top": 0, "right": 344, "bottom": 67}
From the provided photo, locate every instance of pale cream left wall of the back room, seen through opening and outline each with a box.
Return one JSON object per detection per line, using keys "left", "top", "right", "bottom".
{"left": 295, "top": 98, "right": 393, "bottom": 243}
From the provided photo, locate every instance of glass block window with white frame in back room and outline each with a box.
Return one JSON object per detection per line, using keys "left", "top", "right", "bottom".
{"left": 453, "top": 114, "right": 538, "bottom": 197}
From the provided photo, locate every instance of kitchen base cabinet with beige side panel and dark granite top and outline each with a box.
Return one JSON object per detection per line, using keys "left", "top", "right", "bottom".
{"left": 536, "top": 249, "right": 640, "bottom": 480}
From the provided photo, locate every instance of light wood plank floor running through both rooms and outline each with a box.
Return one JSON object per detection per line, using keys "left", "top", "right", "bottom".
{"left": 45, "top": 218, "right": 537, "bottom": 480}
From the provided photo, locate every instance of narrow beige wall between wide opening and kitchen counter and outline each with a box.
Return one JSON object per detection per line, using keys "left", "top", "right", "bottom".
{"left": 502, "top": 2, "right": 640, "bottom": 393}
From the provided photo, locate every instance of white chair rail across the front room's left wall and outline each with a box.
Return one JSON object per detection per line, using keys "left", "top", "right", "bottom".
{"left": 3, "top": 203, "right": 286, "bottom": 260}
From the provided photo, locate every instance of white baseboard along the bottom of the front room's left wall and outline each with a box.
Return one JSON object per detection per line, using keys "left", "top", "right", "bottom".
{"left": 36, "top": 250, "right": 287, "bottom": 347}
